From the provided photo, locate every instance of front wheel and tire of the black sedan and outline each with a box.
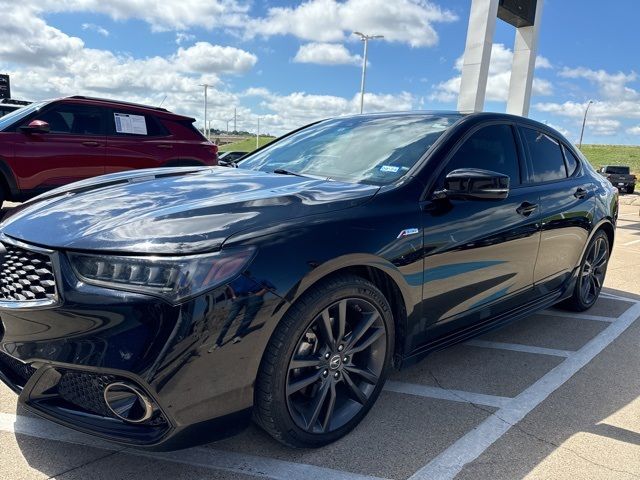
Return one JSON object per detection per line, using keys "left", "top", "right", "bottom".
{"left": 254, "top": 275, "right": 395, "bottom": 447}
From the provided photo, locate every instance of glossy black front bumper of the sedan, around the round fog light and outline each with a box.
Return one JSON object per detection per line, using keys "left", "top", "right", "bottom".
{"left": 0, "top": 238, "right": 281, "bottom": 450}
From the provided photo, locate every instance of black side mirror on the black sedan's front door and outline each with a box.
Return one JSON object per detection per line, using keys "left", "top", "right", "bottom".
{"left": 434, "top": 168, "right": 509, "bottom": 200}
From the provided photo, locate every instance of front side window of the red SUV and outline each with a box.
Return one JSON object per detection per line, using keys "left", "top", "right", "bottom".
{"left": 35, "top": 104, "right": 105, "bottom": 135}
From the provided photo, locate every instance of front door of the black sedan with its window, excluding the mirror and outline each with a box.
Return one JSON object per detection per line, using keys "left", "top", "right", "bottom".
{"left": 421, "top": 123, "right": 540, "bottom": 341}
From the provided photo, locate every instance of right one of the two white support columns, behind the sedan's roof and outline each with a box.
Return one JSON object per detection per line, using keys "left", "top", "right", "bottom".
{"left": 507, "top": 0, "right": 544, "bottom": 117}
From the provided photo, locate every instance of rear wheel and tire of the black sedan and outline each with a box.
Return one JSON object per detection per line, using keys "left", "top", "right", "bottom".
{"left": 562, "top": 230, "right": 611, "bottom": 312}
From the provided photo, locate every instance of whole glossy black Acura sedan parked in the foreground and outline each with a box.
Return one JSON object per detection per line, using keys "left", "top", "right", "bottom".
{"left": 0, "top": 112, "right": 618, "bottom": 449}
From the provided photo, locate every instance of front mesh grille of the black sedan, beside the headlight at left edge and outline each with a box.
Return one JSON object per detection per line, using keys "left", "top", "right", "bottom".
{"left": 0, "top": 243, "right": 56, "bottom": 302}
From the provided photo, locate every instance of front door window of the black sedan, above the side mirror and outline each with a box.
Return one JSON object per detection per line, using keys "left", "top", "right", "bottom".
{"left": 444, "top": 125, "right": 520, "bottom": 186}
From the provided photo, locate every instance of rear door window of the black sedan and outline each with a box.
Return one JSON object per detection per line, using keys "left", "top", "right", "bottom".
{"left": 522, "top": 127, "right": 567, "bottom": 183}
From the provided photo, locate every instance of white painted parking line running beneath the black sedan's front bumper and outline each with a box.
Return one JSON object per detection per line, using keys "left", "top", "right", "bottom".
{"left": 0, "top": 413, "right": 384, "bottom": 480}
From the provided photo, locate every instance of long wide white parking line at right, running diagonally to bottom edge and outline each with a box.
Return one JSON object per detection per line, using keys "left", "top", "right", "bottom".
{"left": 409, "top": 302, "right": 640, "bottom": 480}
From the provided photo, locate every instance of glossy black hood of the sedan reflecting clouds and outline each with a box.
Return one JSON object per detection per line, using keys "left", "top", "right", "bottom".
{"left": 0, "top": 167, "right": 379, "bottom": 254}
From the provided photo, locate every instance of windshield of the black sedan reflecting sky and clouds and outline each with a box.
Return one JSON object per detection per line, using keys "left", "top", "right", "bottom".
{"left": 238, "top": 114, "right": 460, "bottom": 185}
